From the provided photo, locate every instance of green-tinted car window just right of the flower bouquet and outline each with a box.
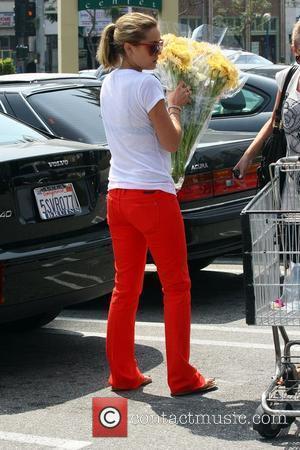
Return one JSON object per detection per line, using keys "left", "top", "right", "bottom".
{"left": 212, "top": 88, "right": 265, "bottom": 117}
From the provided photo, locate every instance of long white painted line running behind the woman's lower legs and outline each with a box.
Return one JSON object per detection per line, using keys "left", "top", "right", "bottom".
{"left": 55, "top": 316, "right": 300, "bottom": 336}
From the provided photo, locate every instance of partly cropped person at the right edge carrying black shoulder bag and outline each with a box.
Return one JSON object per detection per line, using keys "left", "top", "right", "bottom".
{"left": 233, "top": 21, "right": 300, "bottom": 178}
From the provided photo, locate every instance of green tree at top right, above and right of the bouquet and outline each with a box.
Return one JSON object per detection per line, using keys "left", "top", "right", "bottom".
{"left": 213, "top": 0, "right": 272, "bottom": 50}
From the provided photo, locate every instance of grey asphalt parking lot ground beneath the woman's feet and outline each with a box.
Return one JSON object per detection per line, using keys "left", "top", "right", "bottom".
{"left": 0, "top": 258, "right": 300, "bottom": 450}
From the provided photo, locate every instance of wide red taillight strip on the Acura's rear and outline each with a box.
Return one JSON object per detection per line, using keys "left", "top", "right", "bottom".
{"left": 177, "top": 164, "right": 258, "bottom": 202}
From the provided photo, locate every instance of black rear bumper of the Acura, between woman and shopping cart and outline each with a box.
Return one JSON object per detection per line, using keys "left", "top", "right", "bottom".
{"left": 182, "top": 197, "right": 252, "bottom": 260}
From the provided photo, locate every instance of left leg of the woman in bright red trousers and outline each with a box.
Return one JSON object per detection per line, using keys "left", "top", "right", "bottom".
{"left": 106, "top": 190, "right": 147, "bottom": 389}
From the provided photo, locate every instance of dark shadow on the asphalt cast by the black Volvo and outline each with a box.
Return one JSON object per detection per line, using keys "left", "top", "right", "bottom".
{"left": 0, "top": 329, "right": 163, "bottom": 415}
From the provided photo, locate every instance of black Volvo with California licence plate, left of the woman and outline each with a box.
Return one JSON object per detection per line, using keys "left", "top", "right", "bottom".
{"left": 0, "top": 113, "right": 114, "bottom": 330}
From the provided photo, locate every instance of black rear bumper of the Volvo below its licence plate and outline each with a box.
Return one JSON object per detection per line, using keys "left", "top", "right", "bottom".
{"left": 0, "top": 231, "right": 114, "bottom": 323}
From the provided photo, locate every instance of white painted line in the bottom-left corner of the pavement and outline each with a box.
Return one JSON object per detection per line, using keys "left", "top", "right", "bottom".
{"left": 0, "top": 431, "right": 92, "bottom": 450}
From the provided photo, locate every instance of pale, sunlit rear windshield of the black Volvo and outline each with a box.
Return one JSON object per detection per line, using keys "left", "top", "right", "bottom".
{"left": 0, "top": 114, "right": 47, "bottom": 145}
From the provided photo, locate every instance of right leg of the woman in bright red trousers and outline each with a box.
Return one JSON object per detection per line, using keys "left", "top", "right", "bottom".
{"left": 146, "top": 191, "right": 205, "bottom": 393}
